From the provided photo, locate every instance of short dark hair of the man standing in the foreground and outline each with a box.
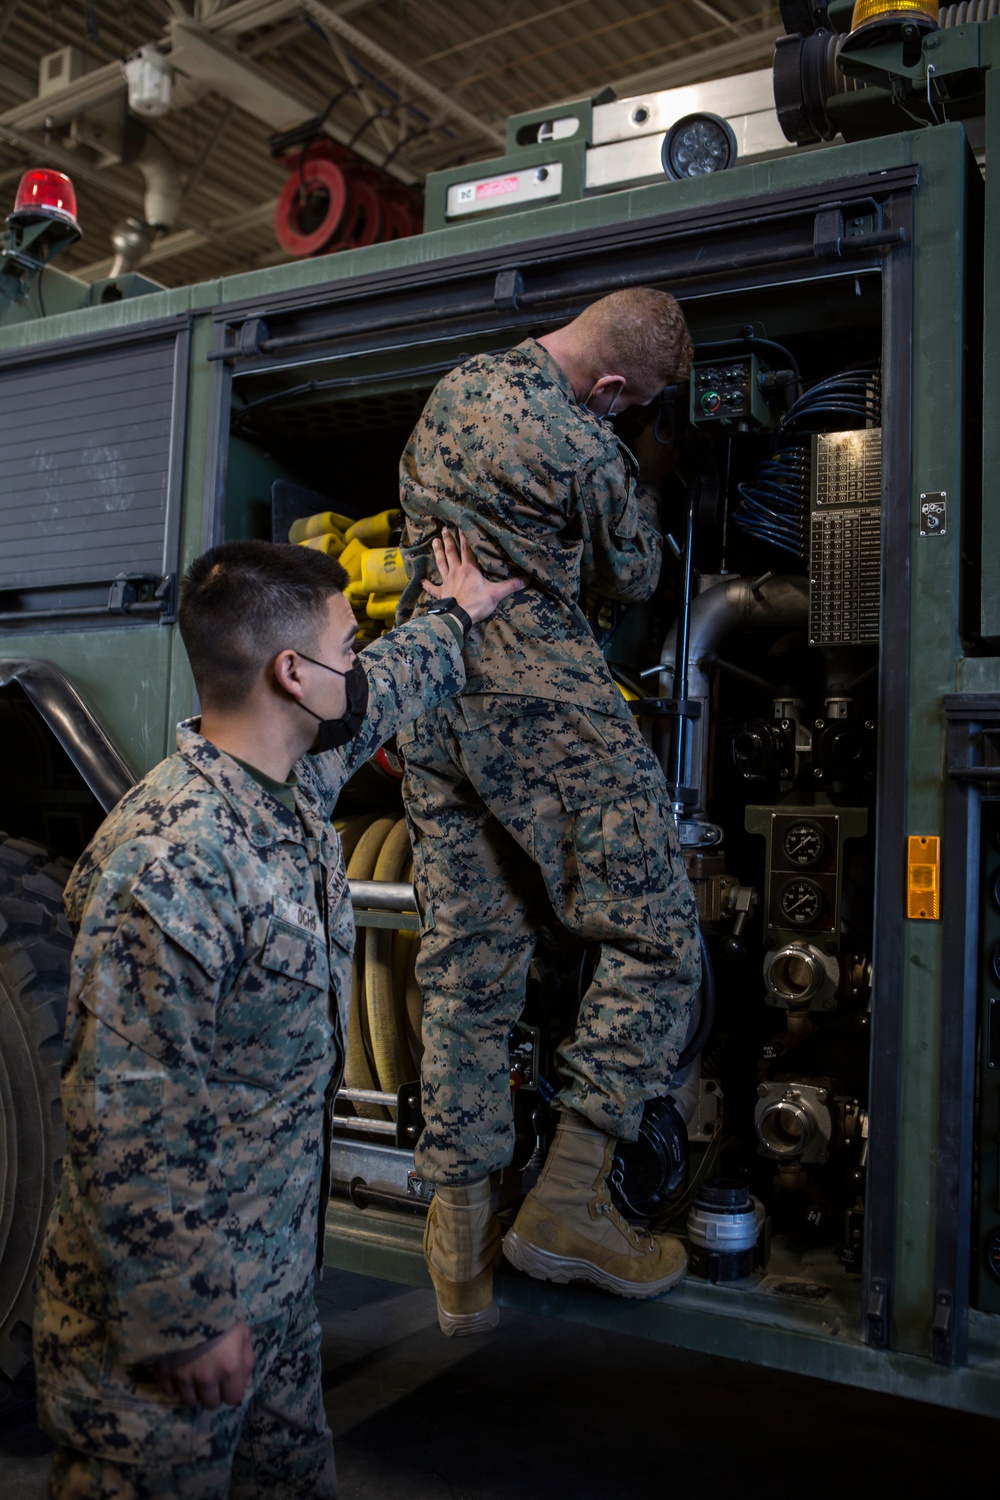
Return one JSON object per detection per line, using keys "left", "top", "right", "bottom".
{"left": 177, "top": 542, "right": 348, "bottom": 708}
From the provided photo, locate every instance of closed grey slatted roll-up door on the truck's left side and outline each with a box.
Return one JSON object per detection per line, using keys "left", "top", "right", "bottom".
{"left": 0, "top": 326, "right": 187, "bottom": 626}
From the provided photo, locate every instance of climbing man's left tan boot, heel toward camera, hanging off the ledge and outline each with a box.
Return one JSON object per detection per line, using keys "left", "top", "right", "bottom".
{"left": 424, "top": 1178, "right": 501, "bottom": 1338}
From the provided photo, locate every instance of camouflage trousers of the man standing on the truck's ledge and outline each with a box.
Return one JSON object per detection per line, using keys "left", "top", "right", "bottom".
{"left": 399, "top": 695, "right": 700, "bottom": 1182}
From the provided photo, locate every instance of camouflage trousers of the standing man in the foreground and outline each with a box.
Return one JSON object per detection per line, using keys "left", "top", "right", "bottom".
{"left": 39, "top": 1287, "right": 337, "bottom": 1500}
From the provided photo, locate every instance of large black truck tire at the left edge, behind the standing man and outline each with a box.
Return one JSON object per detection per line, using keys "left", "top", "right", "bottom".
{"left": 0, "top": 834, "right": 72, "bottom": 1406}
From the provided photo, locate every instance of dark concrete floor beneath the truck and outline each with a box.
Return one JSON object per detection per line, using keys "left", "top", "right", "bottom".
{"left": 0, "top": 1272, "right": 1000, "bottom": 1500}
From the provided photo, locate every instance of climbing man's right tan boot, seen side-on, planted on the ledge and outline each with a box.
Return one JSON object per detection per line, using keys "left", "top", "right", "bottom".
{"left": 504, "top": 1115, "right": 688, "bottom": 1298}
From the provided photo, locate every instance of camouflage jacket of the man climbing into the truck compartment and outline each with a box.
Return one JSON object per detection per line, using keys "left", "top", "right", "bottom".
{"left": 397, "top": 339, "right": 663, "bottom": 714}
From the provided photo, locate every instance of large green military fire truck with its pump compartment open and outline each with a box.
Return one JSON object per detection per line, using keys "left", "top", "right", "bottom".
{"left": 0, "top": 0, "right": 1000, "bottom": 1415}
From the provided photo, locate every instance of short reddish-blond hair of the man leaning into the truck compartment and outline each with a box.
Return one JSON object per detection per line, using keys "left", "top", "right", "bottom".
{"left": 573, "top": 287, "right": 694, "bottom": 390}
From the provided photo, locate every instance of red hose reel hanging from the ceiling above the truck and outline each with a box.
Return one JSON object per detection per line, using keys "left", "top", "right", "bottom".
{"left": 274, "top": 140, "right": 423, "bottom": 257}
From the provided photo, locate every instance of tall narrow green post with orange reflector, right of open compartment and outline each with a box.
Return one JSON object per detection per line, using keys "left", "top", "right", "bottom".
{"left": 893, "top": 126, "right": 970, "bottom": 1355}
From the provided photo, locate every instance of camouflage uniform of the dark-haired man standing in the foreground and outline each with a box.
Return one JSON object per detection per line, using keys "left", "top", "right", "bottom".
{"left": 34, "top": 618, "right": 463, "bottom": 1500}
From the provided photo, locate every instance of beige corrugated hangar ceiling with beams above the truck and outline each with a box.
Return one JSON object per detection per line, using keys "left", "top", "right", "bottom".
{"left": 0, "top": 0, "right": 781, "bottom": 287}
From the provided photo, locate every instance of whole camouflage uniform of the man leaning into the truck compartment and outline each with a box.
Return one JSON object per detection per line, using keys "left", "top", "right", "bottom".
{"left": 400, "top": 339, "right": 699, "bottom": 1182}
